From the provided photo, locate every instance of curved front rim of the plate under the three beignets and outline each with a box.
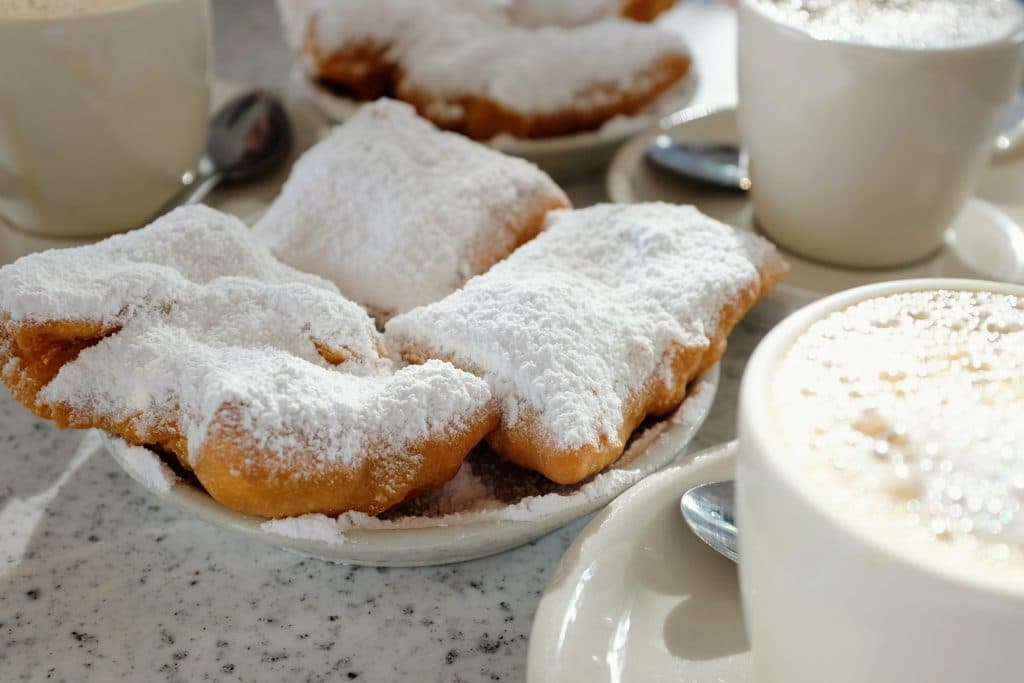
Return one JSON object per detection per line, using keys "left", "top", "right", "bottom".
{"left": 100, "top": 364, "right": 721, "bottom": 566}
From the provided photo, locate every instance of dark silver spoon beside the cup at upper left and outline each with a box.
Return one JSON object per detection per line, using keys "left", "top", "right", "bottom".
{"left": 175, "top": 90, "right": 292, "bottom": 208}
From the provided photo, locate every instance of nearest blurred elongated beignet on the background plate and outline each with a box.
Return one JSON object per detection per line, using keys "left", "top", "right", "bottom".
{"left": 395, "top": 14, "right": 690, "bottom": 140}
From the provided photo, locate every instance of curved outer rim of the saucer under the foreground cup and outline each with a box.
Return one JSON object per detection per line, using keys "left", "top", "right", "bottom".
{"left": 526, "top": 439, "right": 739, "bottom": 683}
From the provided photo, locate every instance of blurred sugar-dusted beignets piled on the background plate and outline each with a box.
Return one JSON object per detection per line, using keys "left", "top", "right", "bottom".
{"left": 299, "top": 0, "right": 690, "bottom": 139}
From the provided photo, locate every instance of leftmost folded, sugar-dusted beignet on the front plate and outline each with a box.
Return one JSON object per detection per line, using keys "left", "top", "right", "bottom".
{"left": 0, "top": 207, "right": 495, "bottom": 516}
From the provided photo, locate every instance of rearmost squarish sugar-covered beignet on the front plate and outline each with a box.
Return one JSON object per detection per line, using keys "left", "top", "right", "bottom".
{"left": 248, "top": 99, "right": 568, "bottom": 317}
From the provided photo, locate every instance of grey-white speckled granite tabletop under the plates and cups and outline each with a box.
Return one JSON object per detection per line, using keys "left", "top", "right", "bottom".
{"left": 0, "top": 0, "right": 753, "bottom": 682}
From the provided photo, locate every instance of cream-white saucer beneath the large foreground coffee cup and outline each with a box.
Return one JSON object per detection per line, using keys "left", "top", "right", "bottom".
{"left": 526, "top": 442, "right": 754, "bottom": 683}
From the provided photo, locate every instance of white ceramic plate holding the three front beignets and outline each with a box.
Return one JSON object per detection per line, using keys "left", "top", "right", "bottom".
{"left": 99, "top": 365, "right": 719, "bottom": 566}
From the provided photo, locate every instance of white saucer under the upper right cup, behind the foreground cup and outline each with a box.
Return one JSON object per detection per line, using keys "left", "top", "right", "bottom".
{"left": 607, "top": 109, "right": 1024, "bottom": 315}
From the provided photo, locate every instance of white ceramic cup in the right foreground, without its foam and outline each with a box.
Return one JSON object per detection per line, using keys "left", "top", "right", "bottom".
{"left": 736, "top": 280, "right": 1024, "bottom": 683}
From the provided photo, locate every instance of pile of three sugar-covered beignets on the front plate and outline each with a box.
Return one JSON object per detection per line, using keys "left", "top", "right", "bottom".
{"left": 0, "top": 102, "right": 784, "bottom": 516}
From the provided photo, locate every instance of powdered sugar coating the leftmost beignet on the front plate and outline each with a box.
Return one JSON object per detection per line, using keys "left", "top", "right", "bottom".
{"left": 0, "top": 207, "right": 489, "bottom": 475}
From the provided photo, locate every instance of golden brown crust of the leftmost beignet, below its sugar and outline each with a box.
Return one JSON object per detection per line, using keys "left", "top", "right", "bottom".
{"left": 0, "top": 317, "right": 499, "bottom": 517}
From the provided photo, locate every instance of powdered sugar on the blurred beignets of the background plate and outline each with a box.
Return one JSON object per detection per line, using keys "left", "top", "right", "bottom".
{"left": 303, "top": 0, "right": 687, "bottom": 115}
